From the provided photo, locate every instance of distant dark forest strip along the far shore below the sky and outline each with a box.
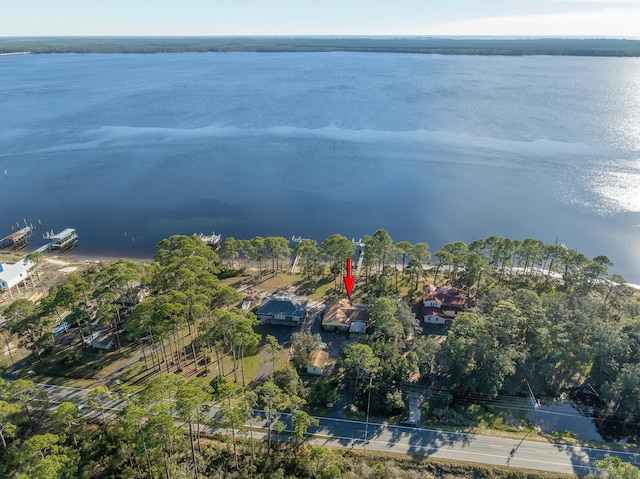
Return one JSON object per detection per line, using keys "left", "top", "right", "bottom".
{"left": 0, "top": 36, "right": 640, "bottom": 57}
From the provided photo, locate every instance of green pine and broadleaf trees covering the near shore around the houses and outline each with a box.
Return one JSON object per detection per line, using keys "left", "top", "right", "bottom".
{"left": 0, "top": 230, "right": 640, "bottom": 478}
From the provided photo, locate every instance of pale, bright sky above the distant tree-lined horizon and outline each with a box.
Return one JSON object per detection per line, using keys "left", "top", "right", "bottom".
{"left": 0, "top": 0, "right": 640, "bottom": 38}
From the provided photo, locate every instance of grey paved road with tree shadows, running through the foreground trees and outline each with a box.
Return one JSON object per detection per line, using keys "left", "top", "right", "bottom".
{"left": 38, "top": 384, "right": 640, "bottom": 475}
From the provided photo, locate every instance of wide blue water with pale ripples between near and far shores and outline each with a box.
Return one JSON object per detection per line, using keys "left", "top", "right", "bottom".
{"left": 0, "top": 53, "right": 640, "bottom": 283}
